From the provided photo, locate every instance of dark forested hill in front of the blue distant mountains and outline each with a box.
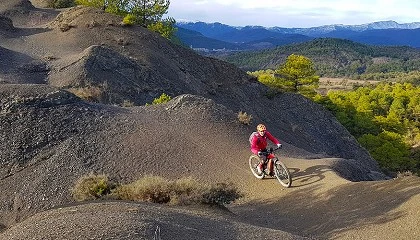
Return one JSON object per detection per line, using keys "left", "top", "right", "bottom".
{"left": 223, "top": 38, "right": 420, "bottom": 83}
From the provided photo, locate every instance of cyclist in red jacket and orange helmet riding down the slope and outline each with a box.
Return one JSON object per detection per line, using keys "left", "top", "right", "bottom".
{"left": 250, "top": 124, "right": 282, "bottom": 176}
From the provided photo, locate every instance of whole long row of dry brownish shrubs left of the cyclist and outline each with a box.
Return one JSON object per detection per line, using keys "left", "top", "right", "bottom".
{"left": 71, "top": 173, "right": 242, "bottom": 205}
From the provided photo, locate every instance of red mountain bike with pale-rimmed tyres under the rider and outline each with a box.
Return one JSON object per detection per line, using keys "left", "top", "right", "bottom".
{"left": 249, "top": 148, "right": 292, "bottom": 188}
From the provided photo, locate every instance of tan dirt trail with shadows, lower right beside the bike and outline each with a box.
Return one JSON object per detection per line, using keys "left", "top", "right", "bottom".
{"left": 229, "top": 159, "right": 420, "bottom": 240}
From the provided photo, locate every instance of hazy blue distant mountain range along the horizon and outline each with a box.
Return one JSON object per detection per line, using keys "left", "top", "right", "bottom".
{"left": 176, "top": 21, "right": 420, "bottom": 51}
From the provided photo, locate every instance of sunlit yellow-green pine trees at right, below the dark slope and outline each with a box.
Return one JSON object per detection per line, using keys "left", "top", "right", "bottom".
{"left": 314, "top": 82, "right": 420, "bottom": 173}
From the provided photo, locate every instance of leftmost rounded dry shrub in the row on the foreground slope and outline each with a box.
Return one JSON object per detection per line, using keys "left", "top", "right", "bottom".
{"left": 71, "top": 173, "right": 114, "bottom": 201}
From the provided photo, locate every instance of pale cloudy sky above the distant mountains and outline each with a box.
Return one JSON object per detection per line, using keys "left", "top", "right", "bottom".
{"left": 167, "top": 0, "right": 420, "bottom": 28}
